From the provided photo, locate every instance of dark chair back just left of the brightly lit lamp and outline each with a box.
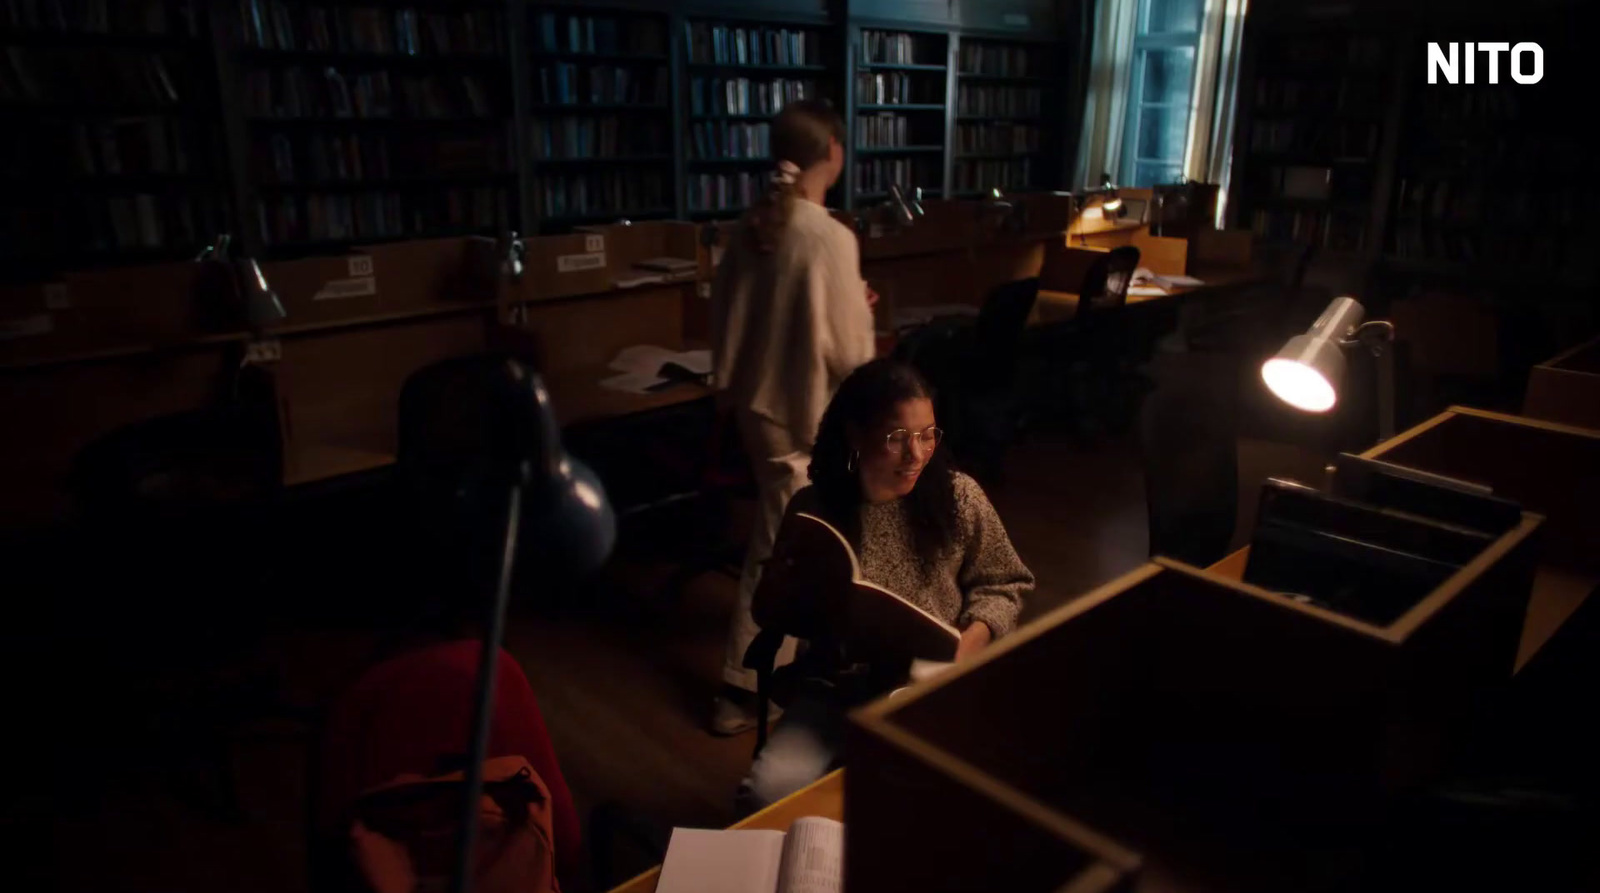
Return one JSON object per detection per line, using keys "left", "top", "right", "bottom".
{"left": 1139, "top": 354, "right": 1238, "bottom": 568}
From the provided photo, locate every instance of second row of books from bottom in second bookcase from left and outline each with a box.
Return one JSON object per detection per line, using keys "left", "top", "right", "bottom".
{"left": 251, "top": 133, "right": 510, "bottom": 184}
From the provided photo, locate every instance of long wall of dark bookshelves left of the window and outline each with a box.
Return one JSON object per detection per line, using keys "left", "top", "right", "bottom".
{"left": 0, "top": 0, "right": 1061, "bottom": 268}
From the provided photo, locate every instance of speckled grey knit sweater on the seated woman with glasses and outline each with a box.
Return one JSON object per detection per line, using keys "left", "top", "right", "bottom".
{"left": 789, "top": 472, "right": 1034, "bottom": 639}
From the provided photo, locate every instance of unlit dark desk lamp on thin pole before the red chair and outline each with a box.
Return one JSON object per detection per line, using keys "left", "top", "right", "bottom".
{"left": 435, "top": 358, "right": 616, "bottom": 893}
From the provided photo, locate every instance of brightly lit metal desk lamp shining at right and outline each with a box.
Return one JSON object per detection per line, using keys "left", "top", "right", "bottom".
{"left": 1261, "top": 296, "right": 1395, "bottom": 440}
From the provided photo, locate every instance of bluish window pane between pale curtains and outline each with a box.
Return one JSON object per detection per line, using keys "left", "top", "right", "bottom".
{"left": 1118, "top": 0, "right": 1205, "bottom": 187}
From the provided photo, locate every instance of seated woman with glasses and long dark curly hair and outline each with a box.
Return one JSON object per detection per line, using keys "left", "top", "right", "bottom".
{"left": 744, "top": 360, "right": 1034, "bottom": 807}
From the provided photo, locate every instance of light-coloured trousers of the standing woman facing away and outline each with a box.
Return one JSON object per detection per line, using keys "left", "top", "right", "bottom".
{"left": 722, "top": 410, "right": 811, "bottom": 691}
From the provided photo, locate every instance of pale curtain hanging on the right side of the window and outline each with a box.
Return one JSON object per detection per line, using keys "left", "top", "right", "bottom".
{"left": 1184, "top": 0, "right": 1250, "bottom": 226}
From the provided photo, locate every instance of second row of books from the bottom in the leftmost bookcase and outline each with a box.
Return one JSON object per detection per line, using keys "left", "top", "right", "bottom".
{"left": 0, "top": 117, "right": 204, "bottom": 176}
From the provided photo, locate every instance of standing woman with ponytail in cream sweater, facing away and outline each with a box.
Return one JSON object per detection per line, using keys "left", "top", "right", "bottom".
{"left": 710, "top": 101, "right": 875, "bottom": 735}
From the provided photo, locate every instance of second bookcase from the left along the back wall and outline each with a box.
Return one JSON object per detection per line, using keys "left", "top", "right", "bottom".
{"left": 229, "top": 0, "right": 515, "bottom": 256}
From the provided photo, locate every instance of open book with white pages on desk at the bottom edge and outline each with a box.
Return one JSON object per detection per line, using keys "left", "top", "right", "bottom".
{"left": 656, "top": 816, "right": 845, "bottom": 893}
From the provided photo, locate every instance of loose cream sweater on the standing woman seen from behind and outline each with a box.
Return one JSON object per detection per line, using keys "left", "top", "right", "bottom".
{"left": 710, "top": 198, "right": 875, "bottom": 451}
